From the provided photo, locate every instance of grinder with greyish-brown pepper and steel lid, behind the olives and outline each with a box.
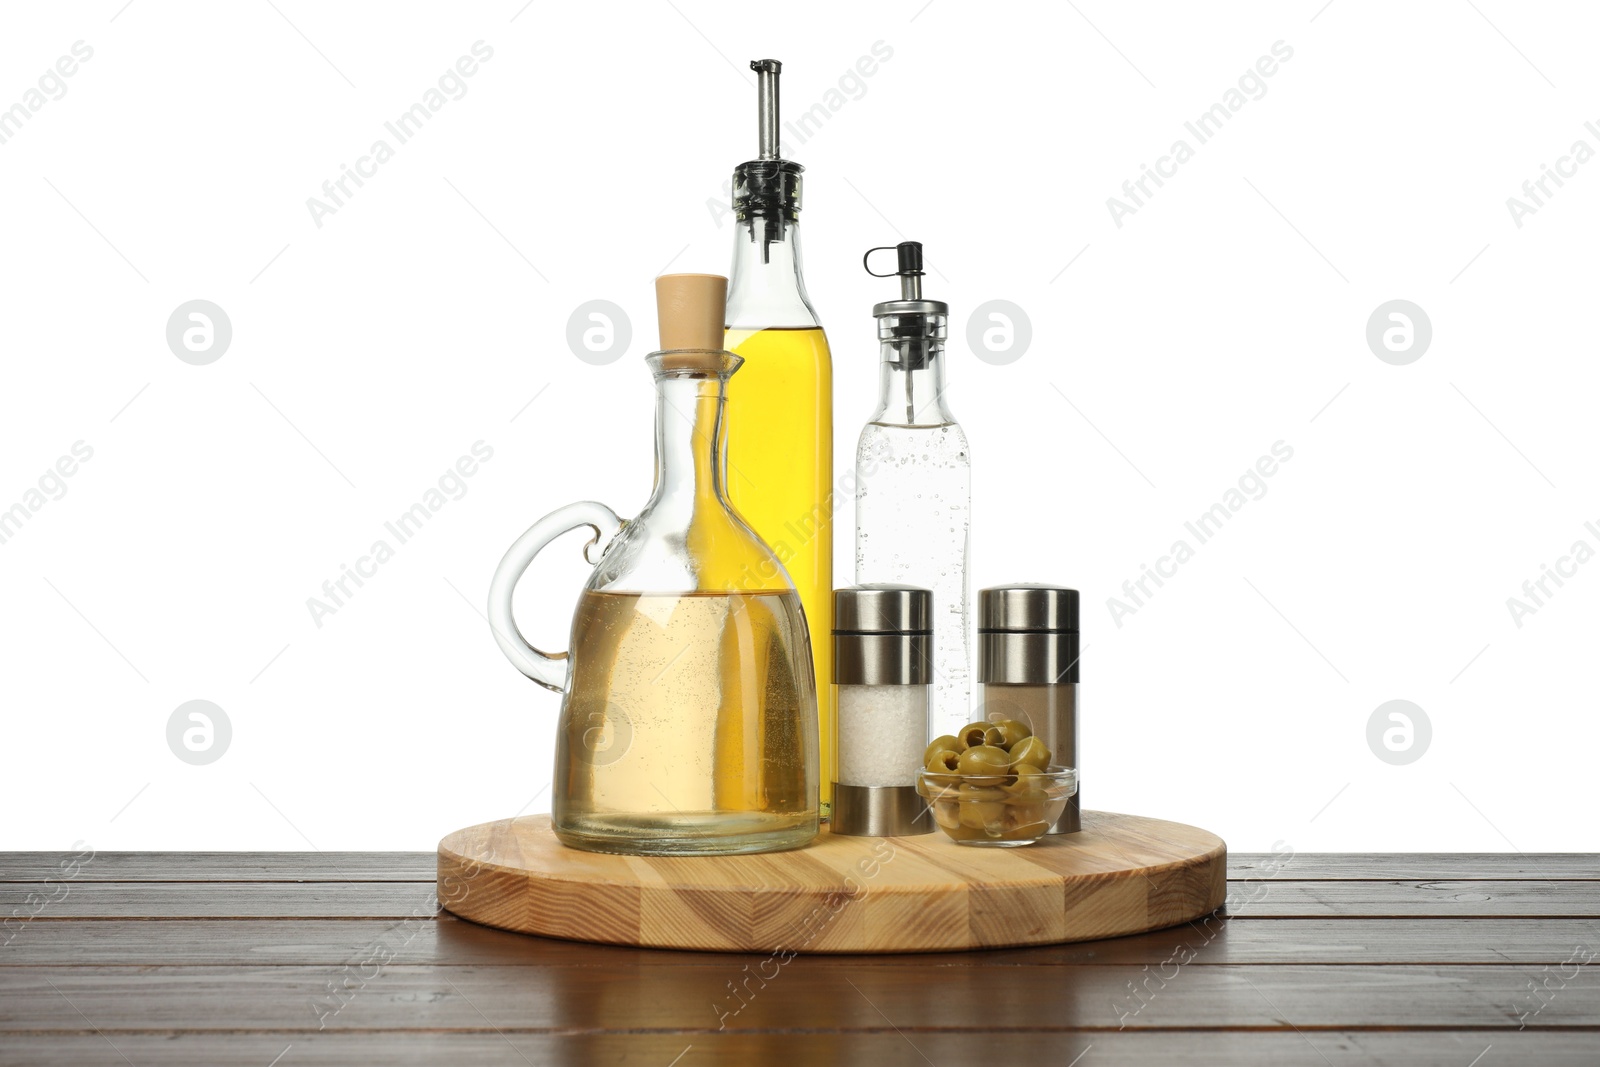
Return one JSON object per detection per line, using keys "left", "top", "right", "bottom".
{"left": 978, "top": 585, "right": 1083, "bottom": 833}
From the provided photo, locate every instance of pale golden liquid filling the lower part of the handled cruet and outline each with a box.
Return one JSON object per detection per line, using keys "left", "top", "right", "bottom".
{"left": 555, "top": 592, "right": 818, "bottom": 854}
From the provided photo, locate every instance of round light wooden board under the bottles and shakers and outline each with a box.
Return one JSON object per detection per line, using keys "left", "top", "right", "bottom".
{"left": 438, "top": 811, "right": 1227, "bottom": 952}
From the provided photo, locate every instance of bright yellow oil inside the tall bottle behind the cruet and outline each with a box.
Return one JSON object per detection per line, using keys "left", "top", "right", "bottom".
{"left": 726, "top": 326, "right": 834, "bottom": 816}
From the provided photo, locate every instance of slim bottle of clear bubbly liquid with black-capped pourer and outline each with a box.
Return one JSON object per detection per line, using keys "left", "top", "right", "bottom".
{"left": 856, "top": 242, "right": 973, "bottom": 736}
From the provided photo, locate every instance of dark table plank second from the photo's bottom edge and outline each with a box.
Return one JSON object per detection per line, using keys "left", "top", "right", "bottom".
{"left": 0, "top": 957, "right": 1600, "bottom": 1032}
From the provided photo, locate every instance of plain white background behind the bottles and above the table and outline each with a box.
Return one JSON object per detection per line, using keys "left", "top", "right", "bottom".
{"left": 0, "top": 0, "right": 1600, "bottom": 851}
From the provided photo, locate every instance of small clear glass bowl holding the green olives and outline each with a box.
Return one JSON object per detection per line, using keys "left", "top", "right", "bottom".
{"left": 917, "top": 766, "right": 1078, "bottom": 848}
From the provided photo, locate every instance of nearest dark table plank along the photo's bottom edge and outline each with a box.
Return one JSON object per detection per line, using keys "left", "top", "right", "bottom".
{"left": 0, "top": 1027, "right": 1595, "bottom": 1067}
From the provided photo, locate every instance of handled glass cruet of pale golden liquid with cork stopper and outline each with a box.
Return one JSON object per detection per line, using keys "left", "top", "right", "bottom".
{"left": 490, "top": 274, "right": 812, "bottom": 856}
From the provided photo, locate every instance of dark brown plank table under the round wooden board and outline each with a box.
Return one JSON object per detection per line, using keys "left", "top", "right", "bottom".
{"left": 0, "top": 853, "right": 1600, "bottom": 1067}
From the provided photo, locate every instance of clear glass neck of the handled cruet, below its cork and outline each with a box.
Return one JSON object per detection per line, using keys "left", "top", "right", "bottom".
{"left": 646, "top": 378, "right": 728, "bottom": 525}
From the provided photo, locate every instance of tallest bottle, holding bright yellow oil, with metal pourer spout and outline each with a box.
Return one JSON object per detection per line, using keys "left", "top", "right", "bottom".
{"left": 725, "top": 59, "right": 834, "bottom": 816}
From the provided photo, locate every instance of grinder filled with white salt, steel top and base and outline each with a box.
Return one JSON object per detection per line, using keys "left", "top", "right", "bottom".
{"left": 829, "top": 585, "right": 933, "bottom": 837}
